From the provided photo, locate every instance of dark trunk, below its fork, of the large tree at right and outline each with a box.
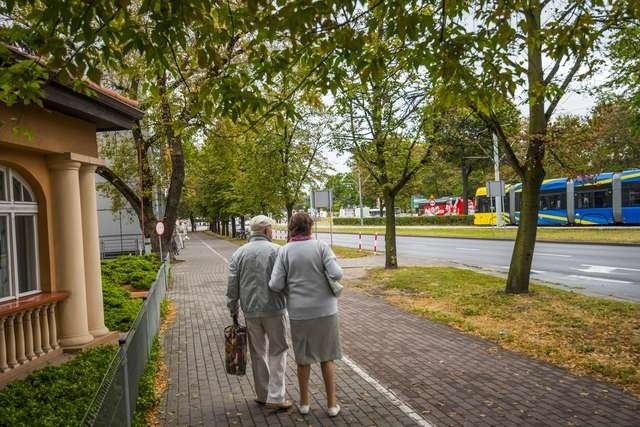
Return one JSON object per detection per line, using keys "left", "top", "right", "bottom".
{"left": 505, "top": 171, "right": 544, "bottom": 294}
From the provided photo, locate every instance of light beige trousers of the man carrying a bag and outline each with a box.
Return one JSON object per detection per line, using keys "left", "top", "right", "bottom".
{"left": 245, "top": 314, "right": 289, "bottom": 403}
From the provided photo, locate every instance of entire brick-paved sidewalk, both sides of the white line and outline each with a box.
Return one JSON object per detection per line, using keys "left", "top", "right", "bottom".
{"left": 161, "top": 234, "right": 640, "bottom": 426}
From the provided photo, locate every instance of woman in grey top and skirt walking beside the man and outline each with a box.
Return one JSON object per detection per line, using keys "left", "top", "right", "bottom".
{"left": 269, "top": 212, "right": 342, "bottom": 417}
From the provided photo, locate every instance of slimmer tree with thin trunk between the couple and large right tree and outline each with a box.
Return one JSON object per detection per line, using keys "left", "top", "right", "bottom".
{"left": 336, "top": 2, "right": 438, "bottom": 268}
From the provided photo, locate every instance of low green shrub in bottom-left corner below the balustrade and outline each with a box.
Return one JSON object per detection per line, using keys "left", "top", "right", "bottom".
{"left": 0, "top": 346, "right": 117, "bottom": 426}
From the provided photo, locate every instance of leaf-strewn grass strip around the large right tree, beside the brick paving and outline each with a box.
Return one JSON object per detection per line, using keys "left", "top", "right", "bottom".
{"left": 354, "top": 267, "right": 640, "bottom": 397}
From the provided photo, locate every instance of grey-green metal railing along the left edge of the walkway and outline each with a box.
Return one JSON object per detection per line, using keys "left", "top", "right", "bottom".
{"left": 82, "top": 261, "right": 169, "bottom": 426}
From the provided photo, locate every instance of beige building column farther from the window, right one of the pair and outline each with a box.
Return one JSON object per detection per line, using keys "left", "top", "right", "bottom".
{"left": 80, "top": 164, "right": 109, "bottom": 337}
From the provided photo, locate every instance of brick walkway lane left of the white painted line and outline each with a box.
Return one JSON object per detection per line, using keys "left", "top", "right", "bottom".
{"left": 160, "top": 234, "right": 415, "bottom": 426}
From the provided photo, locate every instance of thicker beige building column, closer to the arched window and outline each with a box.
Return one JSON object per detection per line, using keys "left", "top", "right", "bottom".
{"left": 49, "top": 158, "right": 93, "bottom": 347}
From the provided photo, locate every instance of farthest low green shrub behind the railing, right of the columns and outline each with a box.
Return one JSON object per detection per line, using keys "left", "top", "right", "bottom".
{"left": 102, "top": 255, "right": 160, "bottom": 289}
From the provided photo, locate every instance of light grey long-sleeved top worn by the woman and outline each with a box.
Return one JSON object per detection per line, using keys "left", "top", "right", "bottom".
{"left": 269, "top": 240, "right": 342, "bottom": 320}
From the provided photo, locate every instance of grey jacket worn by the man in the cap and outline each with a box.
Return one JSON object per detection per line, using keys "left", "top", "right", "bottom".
{"left": 227, "top": 235, "right": 286, "bottom": 317}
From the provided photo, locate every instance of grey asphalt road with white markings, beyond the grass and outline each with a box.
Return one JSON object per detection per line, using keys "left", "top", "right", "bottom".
{"left": 318, "top": 233, "right": 640, "bottom": 301}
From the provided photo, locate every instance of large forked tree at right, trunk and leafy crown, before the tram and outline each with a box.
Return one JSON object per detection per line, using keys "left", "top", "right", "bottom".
{"left": 431, "top": 0, "right": 612, "bottom": 293}
